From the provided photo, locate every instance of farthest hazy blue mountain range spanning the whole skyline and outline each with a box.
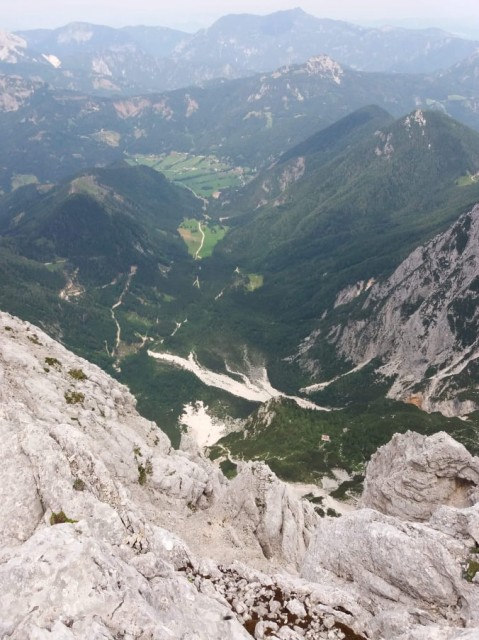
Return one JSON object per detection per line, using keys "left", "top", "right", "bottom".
{"left": 0, "top": 9, "right": 479, "bottom": 95}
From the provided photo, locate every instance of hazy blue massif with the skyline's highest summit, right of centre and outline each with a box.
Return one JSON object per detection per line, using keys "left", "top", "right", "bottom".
{"left": 173, "top": 8, "right": 479, "bottom": 73}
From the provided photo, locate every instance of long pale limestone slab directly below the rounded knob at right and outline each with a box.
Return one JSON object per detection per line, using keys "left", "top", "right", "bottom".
{"left": 303, "top": 509, "right": 472, "bottom": 607}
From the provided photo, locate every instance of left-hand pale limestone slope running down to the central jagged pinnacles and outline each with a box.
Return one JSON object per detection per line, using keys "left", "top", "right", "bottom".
{"left": 0, "top": 314, "right": 324, "bottom": 640}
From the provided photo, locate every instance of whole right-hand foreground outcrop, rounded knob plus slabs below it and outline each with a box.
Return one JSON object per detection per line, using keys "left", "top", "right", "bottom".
{"left": 302, "top": 432, "right": 479, "bottom": 640}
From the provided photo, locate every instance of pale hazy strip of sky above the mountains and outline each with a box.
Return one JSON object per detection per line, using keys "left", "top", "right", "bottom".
{"left": 0, "top": 0, "right": 479, "bottom": 31}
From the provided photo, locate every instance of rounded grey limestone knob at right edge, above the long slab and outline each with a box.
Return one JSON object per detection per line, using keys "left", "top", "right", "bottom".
{"left": 361, "top": 432, "right": 479, "bottom": 522}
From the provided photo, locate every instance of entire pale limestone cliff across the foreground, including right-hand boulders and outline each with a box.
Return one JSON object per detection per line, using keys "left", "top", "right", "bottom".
{"left": 0, "top": 314, "right": 479, "bottom": 640}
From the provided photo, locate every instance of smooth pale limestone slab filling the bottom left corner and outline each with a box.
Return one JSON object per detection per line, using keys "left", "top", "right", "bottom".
{"left": 0, "top": 522, "right": 253, "bottom": 640}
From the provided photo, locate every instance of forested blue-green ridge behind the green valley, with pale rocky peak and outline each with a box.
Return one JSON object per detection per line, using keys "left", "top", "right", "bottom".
{"left": 0, "top": 50, "right": 479, "bottom": 191}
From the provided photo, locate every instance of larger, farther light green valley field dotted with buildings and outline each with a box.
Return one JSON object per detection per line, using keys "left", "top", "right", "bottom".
{"left": 127, "top": 151, "right": 251, "bottom": 198}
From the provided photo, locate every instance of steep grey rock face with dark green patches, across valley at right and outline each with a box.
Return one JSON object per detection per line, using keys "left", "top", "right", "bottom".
{"left": 331, "top": 205, "right": 479, "bottom": 416}
